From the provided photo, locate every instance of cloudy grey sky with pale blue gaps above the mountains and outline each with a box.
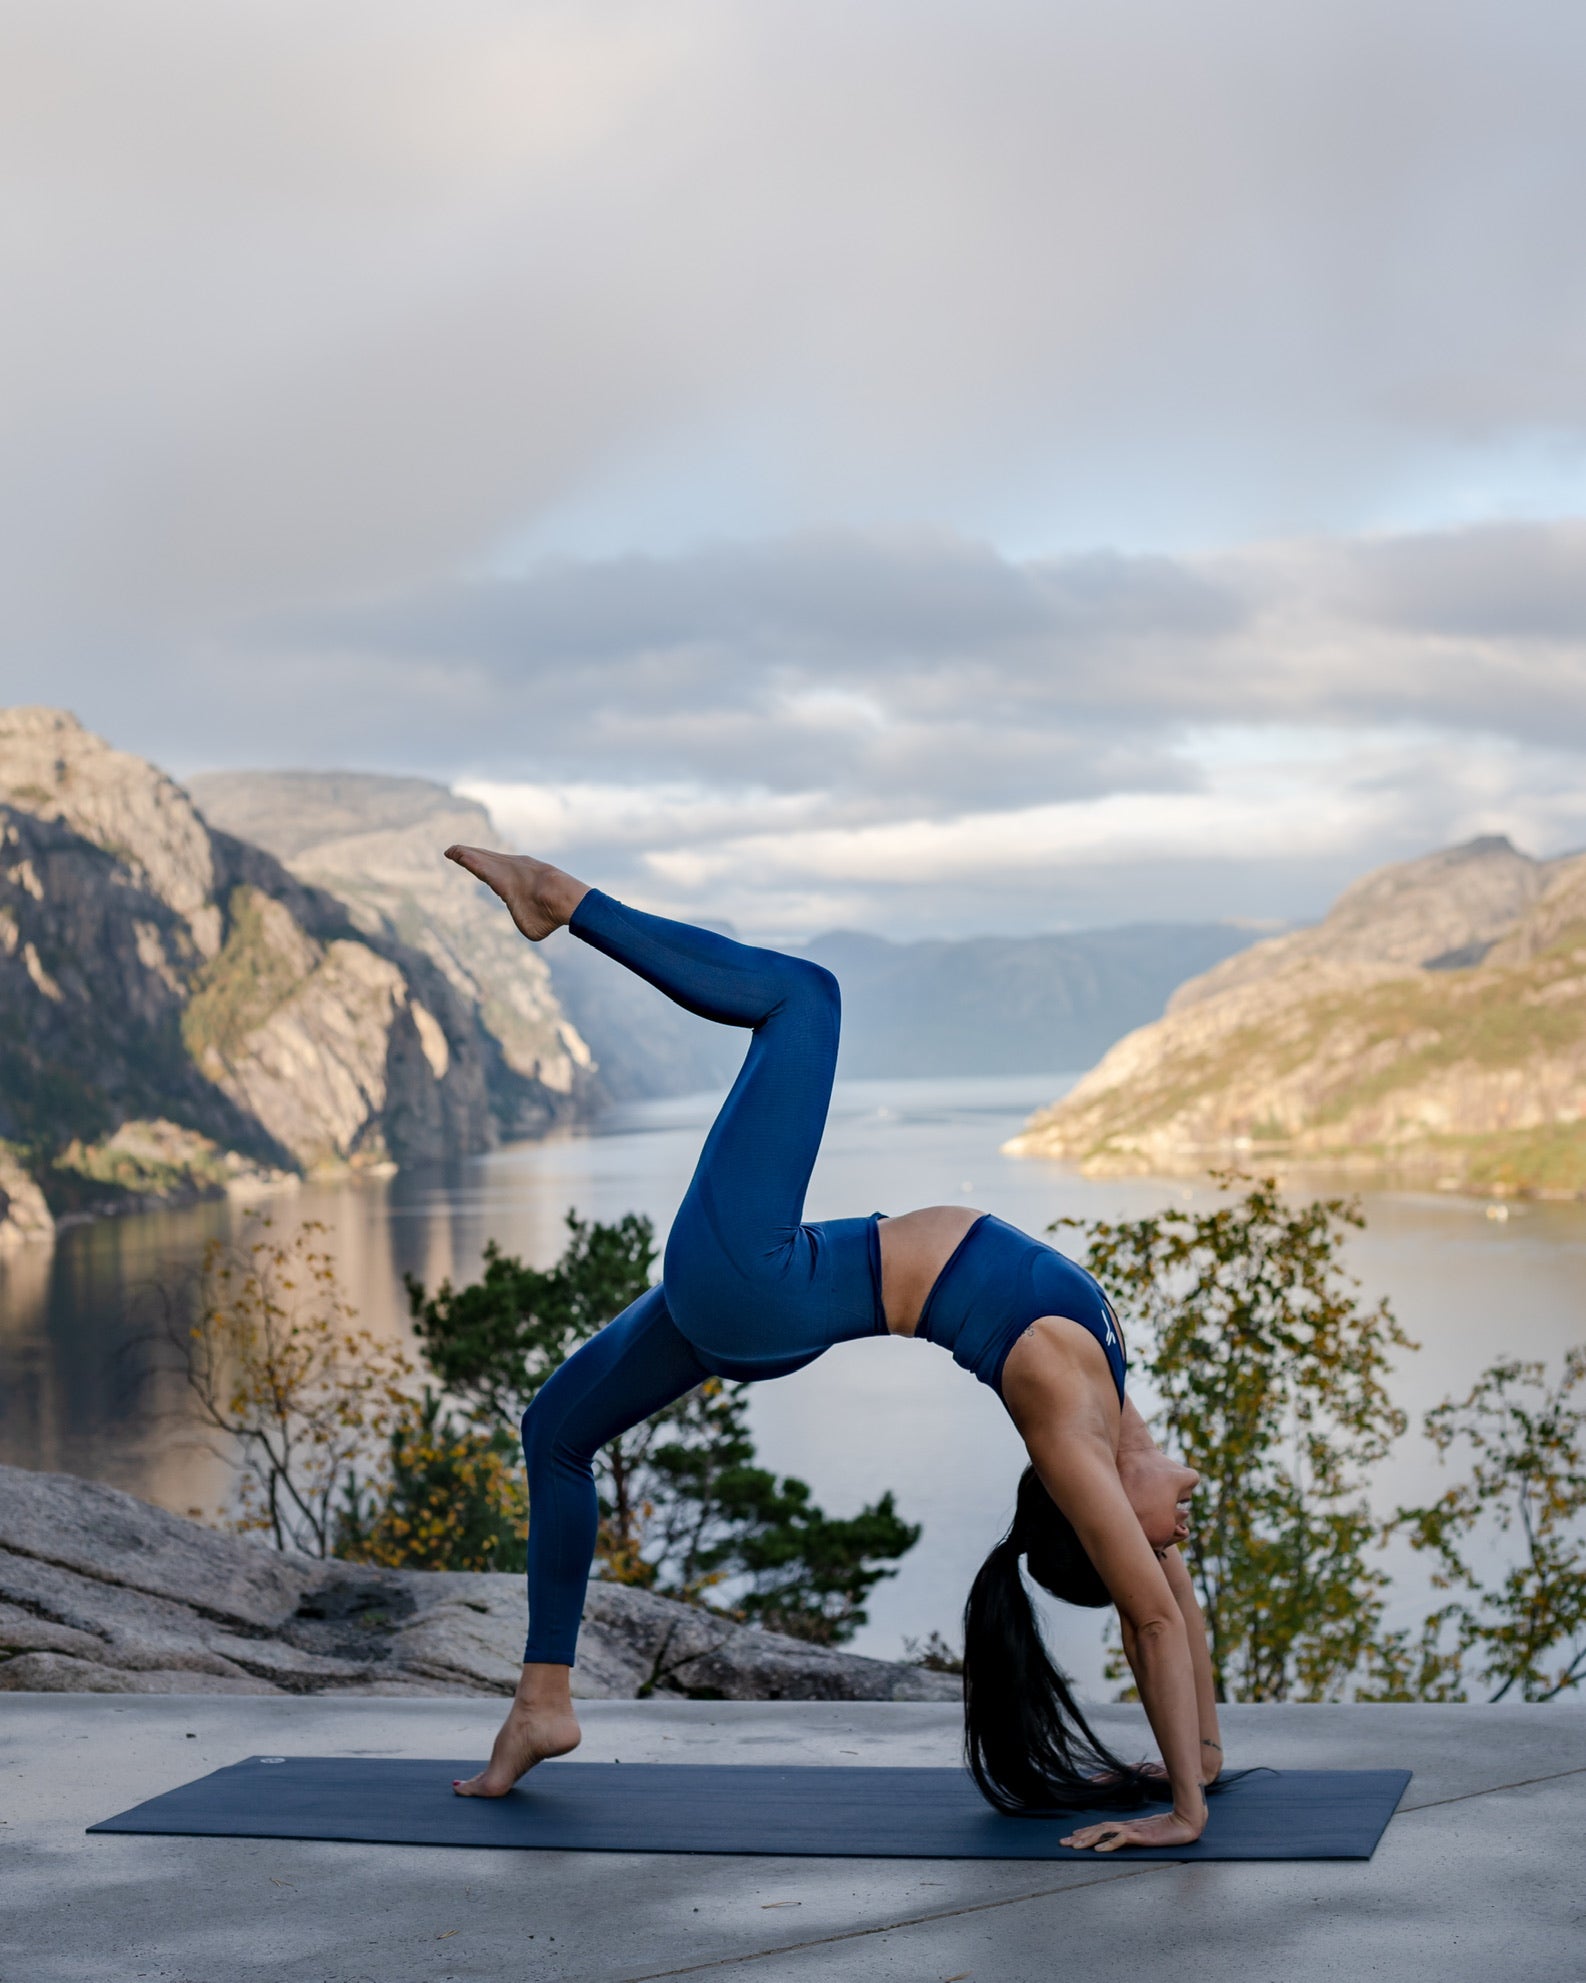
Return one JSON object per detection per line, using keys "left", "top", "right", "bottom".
{"left": 0, "top": 0, "right": 1586, "bottom": 940}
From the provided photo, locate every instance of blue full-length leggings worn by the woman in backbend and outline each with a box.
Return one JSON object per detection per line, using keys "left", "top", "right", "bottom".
{"left": 523, "top": 888, "right": 886, "bottom": 1666}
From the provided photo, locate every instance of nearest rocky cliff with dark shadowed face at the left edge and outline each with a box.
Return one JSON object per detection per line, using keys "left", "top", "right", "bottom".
{"left": 0, "top": 710, "right": 496, "bottom": 1239}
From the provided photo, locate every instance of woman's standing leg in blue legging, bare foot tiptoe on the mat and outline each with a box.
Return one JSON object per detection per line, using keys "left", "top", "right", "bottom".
{"left": 452, "top": 1287, "right": 708, "bottom": 1797}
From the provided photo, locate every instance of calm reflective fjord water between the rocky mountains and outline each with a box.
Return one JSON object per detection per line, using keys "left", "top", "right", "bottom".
{"left": 0, "top": 1075, "right": 1586, "bottom": 1688}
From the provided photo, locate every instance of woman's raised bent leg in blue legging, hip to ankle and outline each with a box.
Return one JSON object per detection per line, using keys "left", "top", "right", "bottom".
{"left": 569, "top": 888, "right": 840, "bottom": 1374}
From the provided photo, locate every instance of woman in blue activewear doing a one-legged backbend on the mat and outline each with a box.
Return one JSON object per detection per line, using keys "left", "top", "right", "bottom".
{"left": 448, "top": 847, "right": 1221, "bottom": 1852}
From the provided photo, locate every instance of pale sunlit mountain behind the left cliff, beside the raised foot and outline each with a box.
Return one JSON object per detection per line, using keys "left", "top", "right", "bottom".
{"left": 188, "top": 771, "right": 597, "bottom": 1136}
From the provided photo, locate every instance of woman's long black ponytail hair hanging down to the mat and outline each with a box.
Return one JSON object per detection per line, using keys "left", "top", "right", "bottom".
{"left": 963, "top": 1467, "right": 1168, "bottom": 1816}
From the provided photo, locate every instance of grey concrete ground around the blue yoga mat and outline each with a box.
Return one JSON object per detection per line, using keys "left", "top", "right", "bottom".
{"left": 0, "top": 1693, "right": 1586, "bottom": 1983}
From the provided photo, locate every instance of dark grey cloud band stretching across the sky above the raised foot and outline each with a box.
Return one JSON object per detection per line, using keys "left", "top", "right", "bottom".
{"left": 256, "top": 524, "right": 1586, "bottom": 765}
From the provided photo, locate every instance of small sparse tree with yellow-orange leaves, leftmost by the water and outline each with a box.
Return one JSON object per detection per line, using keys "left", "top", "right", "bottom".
{"left": 165, "top": 1218, "right": 414, "bottom": 1557}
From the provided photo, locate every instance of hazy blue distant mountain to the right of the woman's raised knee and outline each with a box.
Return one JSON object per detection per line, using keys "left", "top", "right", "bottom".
{"left": 805, "top": 922, "right": 1251, "bottom": 1079}
